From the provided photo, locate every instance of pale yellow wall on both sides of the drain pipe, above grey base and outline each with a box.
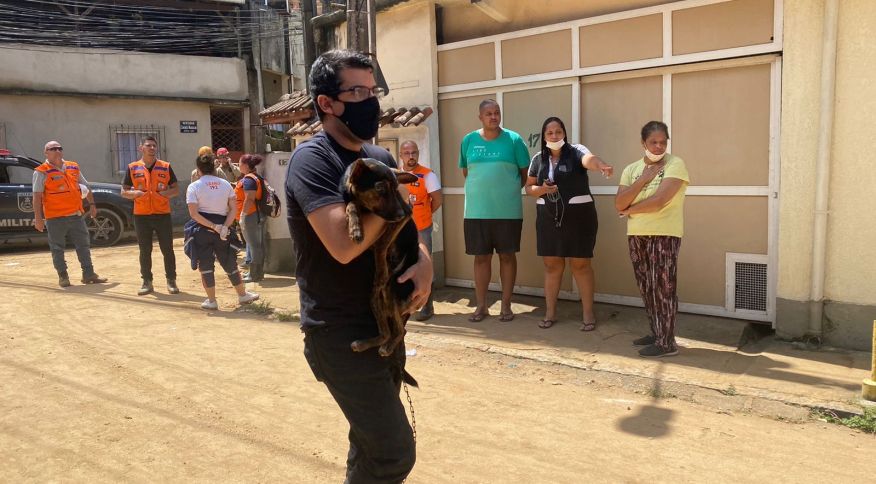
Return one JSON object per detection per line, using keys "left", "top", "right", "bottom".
{"left": 778, "top": 0, "right": 876, "bottom": 305}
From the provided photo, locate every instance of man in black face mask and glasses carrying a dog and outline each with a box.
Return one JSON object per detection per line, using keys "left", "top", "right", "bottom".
{"left": 286, "top": 50, "right": 432, "bottom": 483}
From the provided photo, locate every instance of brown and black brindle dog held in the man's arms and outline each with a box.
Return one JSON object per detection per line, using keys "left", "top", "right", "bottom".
{"left": 341, "top": 158, "right": 419, "bottom": 364}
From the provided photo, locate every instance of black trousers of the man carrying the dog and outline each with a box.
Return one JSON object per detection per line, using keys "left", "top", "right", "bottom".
{"left": 304, "top": 325, "right": 416, "bottom": 484}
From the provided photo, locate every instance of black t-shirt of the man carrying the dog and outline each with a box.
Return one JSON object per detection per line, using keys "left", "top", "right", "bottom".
{"left": 286, "top": 132, "right": 396, "bottom": 329}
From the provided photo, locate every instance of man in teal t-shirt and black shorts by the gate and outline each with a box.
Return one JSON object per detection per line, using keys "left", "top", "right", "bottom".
{"left": 459, "top": 99, "right": 529, "bottom": 323}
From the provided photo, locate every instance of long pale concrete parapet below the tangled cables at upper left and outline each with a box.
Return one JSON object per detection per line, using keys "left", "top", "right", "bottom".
{"left": 0, "top": 45, "right": 247, "bottom": 101}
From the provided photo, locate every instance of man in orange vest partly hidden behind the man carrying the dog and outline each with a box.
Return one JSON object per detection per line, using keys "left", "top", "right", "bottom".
{"left": 399, "top": 140, "right": 441, "bottom": 321}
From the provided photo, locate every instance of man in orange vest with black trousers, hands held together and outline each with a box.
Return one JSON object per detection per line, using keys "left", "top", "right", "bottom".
{"left": 122, "top": 136, "right": 179, "bottom": 296}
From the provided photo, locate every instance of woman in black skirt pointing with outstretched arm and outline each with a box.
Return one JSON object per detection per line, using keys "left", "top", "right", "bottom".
{"left": 524, "top": 117, "right": 614, "bottom": 331}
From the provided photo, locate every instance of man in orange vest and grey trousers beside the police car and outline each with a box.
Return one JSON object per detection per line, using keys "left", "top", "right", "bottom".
{"left": 33, "top": 141, "right": 106, "bottom": 287}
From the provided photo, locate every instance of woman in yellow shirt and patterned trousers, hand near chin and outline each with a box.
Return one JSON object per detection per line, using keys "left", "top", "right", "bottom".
{"left": 615, "top": 121, "right": 690, "bottom": 358}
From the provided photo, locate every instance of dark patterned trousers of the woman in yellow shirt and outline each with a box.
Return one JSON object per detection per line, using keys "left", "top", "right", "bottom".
{"left": 628, "top": 235, "right": 681, "bottom": 351}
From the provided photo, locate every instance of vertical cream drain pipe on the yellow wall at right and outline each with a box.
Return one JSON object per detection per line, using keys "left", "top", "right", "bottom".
{"left": 808, "top": 0, "right": 839, "bottom": 341}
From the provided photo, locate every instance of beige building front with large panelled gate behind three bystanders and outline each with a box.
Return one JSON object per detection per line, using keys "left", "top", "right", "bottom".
{"left": 346, "top": 0, "right": 876, "bottom": 349}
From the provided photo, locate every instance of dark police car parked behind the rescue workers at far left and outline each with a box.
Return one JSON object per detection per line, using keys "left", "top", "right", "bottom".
{"left": 0, "top": 150, "right": 134, "bottom": 247}
